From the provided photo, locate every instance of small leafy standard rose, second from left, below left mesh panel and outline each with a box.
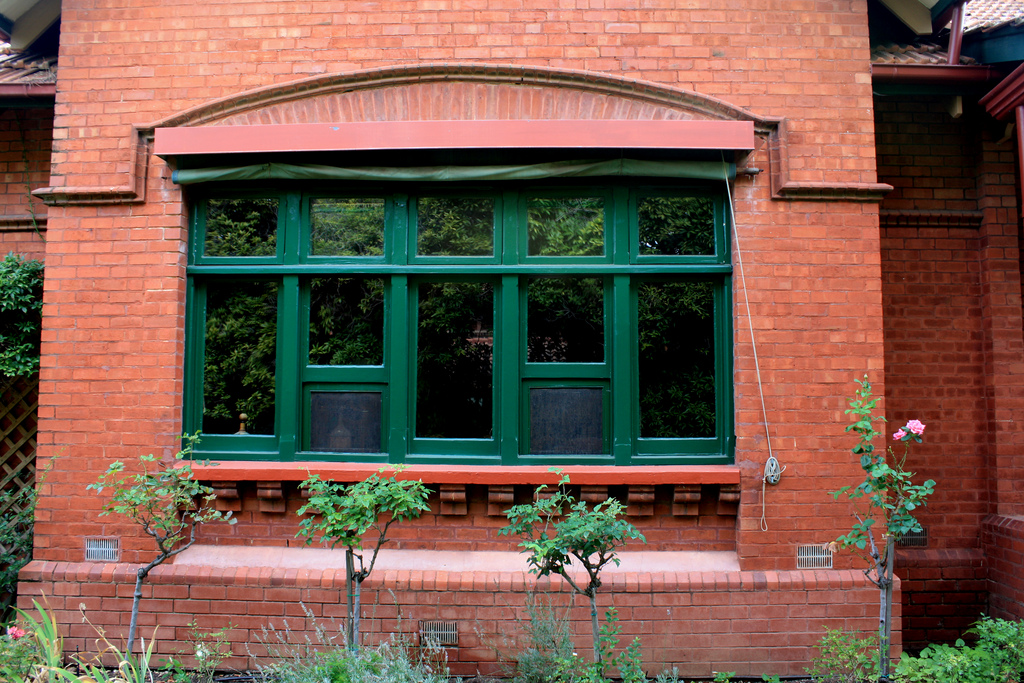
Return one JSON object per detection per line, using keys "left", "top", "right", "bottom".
{"left": 296, "top": 468, "right": 430, "bottom": 650}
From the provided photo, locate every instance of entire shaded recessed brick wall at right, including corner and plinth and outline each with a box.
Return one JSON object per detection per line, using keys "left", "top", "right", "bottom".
{"left": 876, "top": 97, "right": 1022, "bottom": 648}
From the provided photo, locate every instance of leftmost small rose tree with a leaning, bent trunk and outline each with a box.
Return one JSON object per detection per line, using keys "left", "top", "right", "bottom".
{"left": 87, "top": 432, "right": 236, "bottom": 656}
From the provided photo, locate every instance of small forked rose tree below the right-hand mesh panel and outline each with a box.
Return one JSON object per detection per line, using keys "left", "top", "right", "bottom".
{"left": 500, "top": 470, "right": 646, "bottom": 672}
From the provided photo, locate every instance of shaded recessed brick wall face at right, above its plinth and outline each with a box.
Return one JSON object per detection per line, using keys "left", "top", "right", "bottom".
{"left": 876, "top": 97, "right": 989, "bottom": 548}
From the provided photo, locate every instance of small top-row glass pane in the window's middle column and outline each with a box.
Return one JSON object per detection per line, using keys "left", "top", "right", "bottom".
{"left": 416, "top": 197, "right": 495, "bottom": 256}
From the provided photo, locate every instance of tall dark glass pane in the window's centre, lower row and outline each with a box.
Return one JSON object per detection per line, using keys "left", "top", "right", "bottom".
{"left": 416, "top": 283, "right": 495, "bottom": 438}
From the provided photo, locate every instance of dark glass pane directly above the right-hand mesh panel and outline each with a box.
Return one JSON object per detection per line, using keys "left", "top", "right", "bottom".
{"left": 526, "top": 278, "right": 604, "bottom": 362}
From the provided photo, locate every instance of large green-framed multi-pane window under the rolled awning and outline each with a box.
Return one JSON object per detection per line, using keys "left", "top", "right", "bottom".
{"left": 185, "top": 181, "right": 732, "bottom": 465}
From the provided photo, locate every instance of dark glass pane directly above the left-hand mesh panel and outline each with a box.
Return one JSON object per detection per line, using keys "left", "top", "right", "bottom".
{"left": 309, "top": 278, "right": 384, "bottom": 366}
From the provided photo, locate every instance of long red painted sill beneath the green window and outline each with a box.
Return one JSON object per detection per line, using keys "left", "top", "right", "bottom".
{"left": 193, "top": 461, "right": 739, "bottom": 486}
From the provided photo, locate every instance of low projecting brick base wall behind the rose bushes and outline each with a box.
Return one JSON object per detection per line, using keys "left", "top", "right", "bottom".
{"left": 18, "top": 562, "right": 900, "bottom": 678}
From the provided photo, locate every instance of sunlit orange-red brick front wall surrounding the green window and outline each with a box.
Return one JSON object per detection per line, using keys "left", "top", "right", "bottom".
{"left": 24, "top": 0, "right": 897, "bottom": 673}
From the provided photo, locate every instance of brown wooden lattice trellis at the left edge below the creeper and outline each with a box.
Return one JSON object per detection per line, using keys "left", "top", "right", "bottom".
{"left": 0, "top": 377, "right": 39, "bottom": 609}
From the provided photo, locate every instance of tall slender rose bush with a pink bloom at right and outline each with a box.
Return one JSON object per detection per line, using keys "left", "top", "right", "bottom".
{"left": 831, "top": 376, "right": 935, "bottom": 681}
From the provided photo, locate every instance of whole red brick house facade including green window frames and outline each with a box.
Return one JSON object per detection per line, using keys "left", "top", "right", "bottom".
{"left": 0, "top": 0, "right": 1024, "bottom": 676}
